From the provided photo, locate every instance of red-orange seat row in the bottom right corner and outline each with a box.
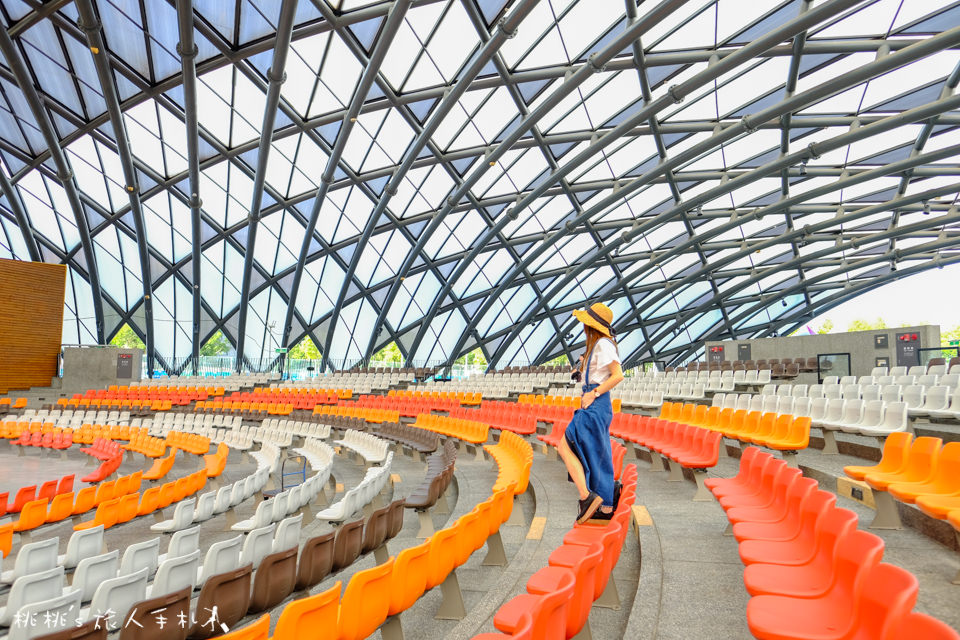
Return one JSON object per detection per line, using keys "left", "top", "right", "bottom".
{"left": 707, "top": 447, "right": 960, "bottom": 640}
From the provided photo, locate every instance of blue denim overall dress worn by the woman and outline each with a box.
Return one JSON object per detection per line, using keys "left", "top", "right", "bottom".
{"left": 564, "top": 338, "right": 613, "bottom": 507}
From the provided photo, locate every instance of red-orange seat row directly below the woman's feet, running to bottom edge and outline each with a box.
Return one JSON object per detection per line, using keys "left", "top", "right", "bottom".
{"left": 474, "top": 465, "right": 637, "bottom": 640}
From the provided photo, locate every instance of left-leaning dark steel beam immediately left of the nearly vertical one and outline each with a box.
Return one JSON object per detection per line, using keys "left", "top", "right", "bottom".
{"left": 76, "top": 0, "right": 156, "bottom": 377}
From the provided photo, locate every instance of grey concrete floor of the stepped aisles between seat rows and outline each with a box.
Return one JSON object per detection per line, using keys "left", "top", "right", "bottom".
{"left": 0, "top": 418, "right": 960, "bottom": 640}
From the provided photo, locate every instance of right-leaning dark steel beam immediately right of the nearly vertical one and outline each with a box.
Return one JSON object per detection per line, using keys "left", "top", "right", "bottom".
{"left": 236, "top": 0, "right": 297, "bottom": 372}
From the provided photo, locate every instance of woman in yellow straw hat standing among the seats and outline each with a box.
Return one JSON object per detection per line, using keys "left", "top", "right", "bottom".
{"left": 559, "top": 303, "right": 623, "bottom": 523}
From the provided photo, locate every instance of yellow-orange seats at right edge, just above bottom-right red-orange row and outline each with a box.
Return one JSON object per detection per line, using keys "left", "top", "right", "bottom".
{"left": 843, "top": 432, "right": 960, "bottom": 535}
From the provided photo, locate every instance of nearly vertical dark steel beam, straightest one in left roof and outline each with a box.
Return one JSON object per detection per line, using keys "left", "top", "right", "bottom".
{"left": 177, "top": 0, "right": 203, "bottom": 375}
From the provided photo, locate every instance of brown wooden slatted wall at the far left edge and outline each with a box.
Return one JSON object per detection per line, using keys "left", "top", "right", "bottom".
{"left": 0, "top": 259, "right": 67, "bottom": 393}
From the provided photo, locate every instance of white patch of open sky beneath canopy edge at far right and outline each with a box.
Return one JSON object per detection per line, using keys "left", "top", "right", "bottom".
{"left": 801, "top": 265, "right": 960, "bottom": 333}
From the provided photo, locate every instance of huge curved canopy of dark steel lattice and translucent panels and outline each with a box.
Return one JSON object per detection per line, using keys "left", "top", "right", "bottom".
{"left": 0, "top": 0, "right": 960, "bottom": 368}
